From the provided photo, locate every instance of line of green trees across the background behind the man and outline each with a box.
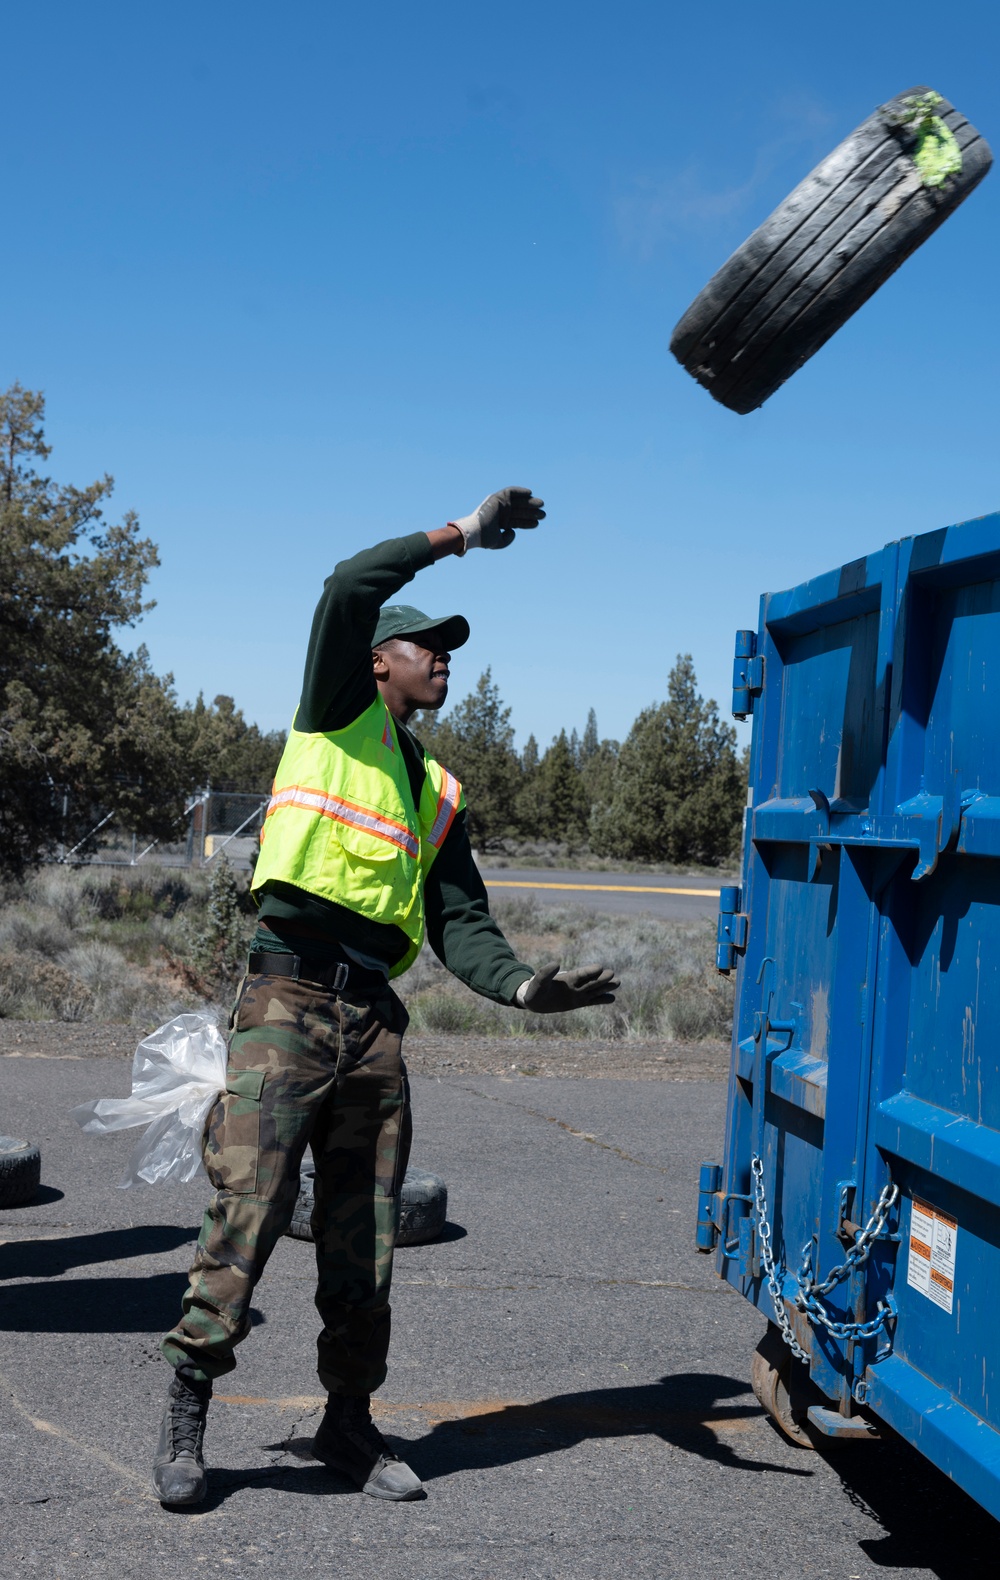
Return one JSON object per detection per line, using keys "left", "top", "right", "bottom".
{"left": 0, "top": 384, "right": 746, "bottom": 874}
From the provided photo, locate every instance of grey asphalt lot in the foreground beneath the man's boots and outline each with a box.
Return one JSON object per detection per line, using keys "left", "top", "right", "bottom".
{"left": 0, "top": 1057, "right": 997, "bottom": 1580}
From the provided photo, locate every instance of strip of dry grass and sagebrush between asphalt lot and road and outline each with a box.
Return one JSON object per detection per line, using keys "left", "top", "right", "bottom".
{"left": 0, "top": 866, "right": 733, "bottom": 1043}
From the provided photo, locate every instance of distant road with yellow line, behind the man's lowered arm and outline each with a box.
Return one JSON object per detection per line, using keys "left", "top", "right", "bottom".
{"left": 480, "top": 867, "right": 719, "bottom": 921}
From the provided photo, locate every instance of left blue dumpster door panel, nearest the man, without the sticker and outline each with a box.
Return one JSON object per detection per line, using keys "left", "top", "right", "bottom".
{"left": 719, "top": 548, "right": 899, "bottom": 1403}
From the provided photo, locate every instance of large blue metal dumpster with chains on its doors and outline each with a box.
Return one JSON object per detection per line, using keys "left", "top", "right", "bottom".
{"left": 698, "top": 515, "right": 1000, "bottom": 1518}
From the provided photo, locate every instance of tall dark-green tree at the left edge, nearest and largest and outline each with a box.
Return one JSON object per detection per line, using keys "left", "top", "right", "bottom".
{"left": 0, "top": 384, "right": 197, "bottom": 872}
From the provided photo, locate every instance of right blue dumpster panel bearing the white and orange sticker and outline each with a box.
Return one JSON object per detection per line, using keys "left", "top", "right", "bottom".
{"left": 867, "top": 517, "right": 1000, "bottom": 1517}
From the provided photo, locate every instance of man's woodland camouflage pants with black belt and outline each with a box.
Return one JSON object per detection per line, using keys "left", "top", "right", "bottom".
{"left": 161, "top": 975, "right": 411, "bottom": 1394}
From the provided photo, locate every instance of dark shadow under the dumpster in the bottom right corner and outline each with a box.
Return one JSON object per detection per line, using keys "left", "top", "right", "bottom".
{"left": 818, "top": 1438, "right": 1000, "bottom": 1580}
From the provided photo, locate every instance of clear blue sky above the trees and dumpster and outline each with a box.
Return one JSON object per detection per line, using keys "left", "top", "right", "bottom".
{"left": 7, "top": 0, "right": 1000, "bottom": 743}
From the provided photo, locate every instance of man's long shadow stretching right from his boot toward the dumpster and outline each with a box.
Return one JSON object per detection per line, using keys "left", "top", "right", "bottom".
{"left": 406, "top": 1371, "right": 814, "bottom": 1480}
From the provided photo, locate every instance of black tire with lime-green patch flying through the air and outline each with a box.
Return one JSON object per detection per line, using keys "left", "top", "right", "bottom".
{"left": 670, "top": 87, "right": 994, "bottom": 414}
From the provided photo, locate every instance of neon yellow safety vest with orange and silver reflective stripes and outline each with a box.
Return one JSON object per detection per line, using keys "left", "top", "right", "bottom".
{"left": 251, "top": 697, "right": 464, "bottom": 976}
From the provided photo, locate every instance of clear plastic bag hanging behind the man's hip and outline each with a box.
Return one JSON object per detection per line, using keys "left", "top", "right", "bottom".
{"left": 70, "top": 1014, "right": 226, "bottom": 1188}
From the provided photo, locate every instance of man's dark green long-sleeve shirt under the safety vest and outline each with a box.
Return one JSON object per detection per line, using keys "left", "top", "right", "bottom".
{"left": 261, "top": 532, "right": 532, "bottom": 1003}
